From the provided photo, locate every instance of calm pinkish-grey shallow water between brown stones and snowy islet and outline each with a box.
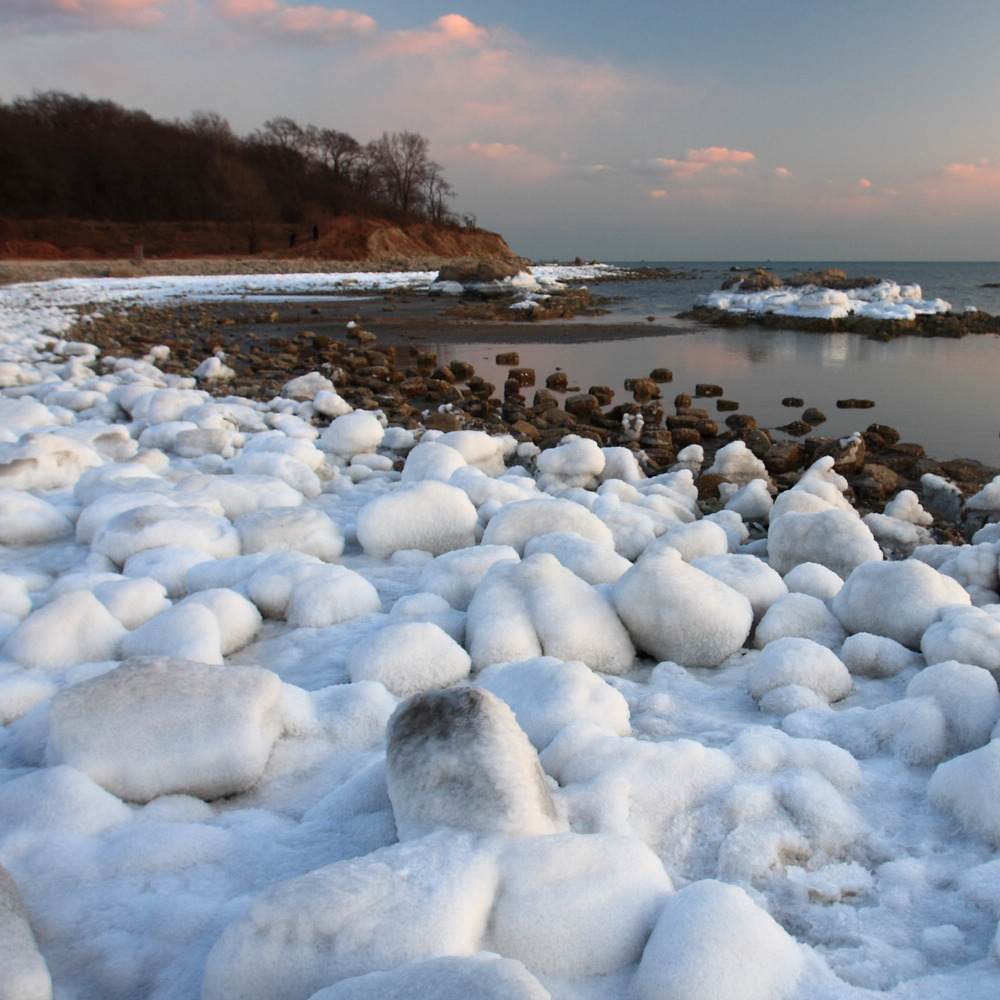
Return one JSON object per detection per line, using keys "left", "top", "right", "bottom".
{"left": 421, "top": 329, "right": 1000, "bottom": 466}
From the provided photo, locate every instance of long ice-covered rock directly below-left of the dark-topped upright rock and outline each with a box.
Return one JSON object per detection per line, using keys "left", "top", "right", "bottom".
{"left": 201, "top": 830, "right": 499, "bottom": 1000}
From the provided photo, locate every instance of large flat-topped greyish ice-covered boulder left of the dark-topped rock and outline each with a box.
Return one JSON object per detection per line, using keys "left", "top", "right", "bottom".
{"left": 46, "top": 657, "right": 283, "bottom": 802}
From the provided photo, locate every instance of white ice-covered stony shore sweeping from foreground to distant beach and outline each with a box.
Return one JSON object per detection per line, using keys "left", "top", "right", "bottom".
{"left": 0, "top": 268, "right": 1000, "bottom": 1000}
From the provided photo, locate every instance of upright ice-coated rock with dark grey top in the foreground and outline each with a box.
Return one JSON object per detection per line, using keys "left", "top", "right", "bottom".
{"left": 385, "top": 688, "right": 557, "bottom": 841}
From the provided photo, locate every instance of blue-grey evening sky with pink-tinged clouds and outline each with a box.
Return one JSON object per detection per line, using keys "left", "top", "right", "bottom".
{"left": 0, "top": 0, "right": 1000, "bottom": 261}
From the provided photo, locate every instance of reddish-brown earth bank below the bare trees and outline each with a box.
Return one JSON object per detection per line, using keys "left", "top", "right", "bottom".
{"left": 0, "top": 215, "right": 523, "bottom": 267}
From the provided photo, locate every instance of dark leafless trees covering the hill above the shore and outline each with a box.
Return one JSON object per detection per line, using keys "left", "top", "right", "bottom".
{"left": 0, "top": 91, "right": 460, "bottom": 238}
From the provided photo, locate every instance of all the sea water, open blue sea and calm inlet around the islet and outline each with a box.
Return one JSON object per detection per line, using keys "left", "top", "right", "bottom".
{"left": 425, "top": 261, "right": 1000, "bottom": 468}
